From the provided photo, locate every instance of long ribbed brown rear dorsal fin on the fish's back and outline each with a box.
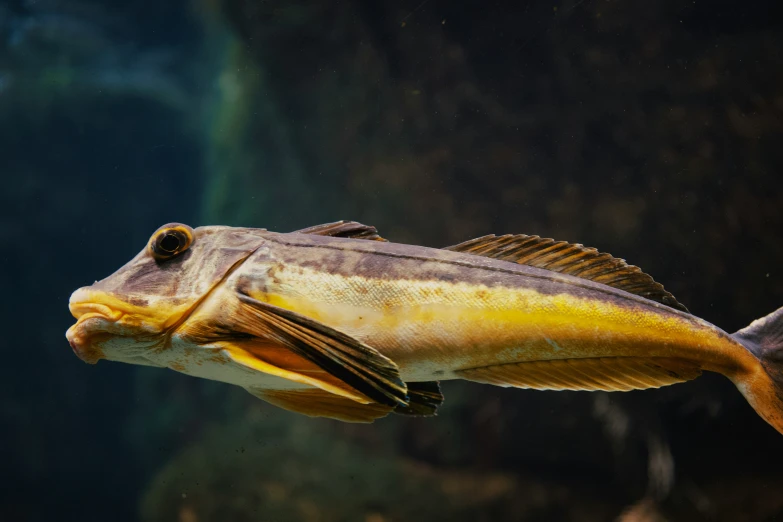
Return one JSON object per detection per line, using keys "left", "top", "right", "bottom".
{"left": 444, "top": 234, "right": 688, "bottom": 312}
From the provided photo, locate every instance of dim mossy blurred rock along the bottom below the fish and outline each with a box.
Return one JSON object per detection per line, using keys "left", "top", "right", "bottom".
{"left": 141, "top": 408, "right": 612, "bottom": 522}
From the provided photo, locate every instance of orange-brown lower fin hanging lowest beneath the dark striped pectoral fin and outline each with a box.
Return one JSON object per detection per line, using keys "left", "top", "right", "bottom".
{"left": 247, "top": 388, "right": 393, "bottom": 423}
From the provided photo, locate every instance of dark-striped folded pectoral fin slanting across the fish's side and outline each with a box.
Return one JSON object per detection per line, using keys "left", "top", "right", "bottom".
{"left": 234, "top": 294, "right": 408, "bottom": 407}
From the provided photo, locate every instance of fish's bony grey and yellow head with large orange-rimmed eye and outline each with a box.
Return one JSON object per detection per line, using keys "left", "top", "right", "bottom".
{"left": 66, "top": 223, "right": 264, "bottom": 364}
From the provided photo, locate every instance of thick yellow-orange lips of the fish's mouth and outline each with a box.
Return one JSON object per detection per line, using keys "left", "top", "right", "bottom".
{"left": 65, "top": 289, "right": 124, "bottom": 364}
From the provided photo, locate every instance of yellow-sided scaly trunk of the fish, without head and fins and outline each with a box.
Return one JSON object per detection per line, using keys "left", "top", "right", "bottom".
{"left": 211, "top": 233, "right": 747, "bottom": 381}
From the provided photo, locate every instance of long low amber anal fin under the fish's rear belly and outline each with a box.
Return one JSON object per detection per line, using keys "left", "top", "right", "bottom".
{"left": 456, "top": 357, "right": 701, "bottom": 391}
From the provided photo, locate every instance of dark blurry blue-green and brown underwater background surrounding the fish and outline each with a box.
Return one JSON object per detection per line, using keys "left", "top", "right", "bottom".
{"left": 0, "top": 0, "right": 783, "bottom": 522}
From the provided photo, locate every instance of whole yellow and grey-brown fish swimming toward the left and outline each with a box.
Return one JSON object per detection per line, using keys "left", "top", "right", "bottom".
{"left": 66, "top": 221, "right": 783, "bottom": 433}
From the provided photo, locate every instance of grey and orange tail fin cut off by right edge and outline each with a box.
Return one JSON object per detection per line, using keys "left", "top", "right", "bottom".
{"left": 731, "top": 308, "right": 783, "bottom": 433}
